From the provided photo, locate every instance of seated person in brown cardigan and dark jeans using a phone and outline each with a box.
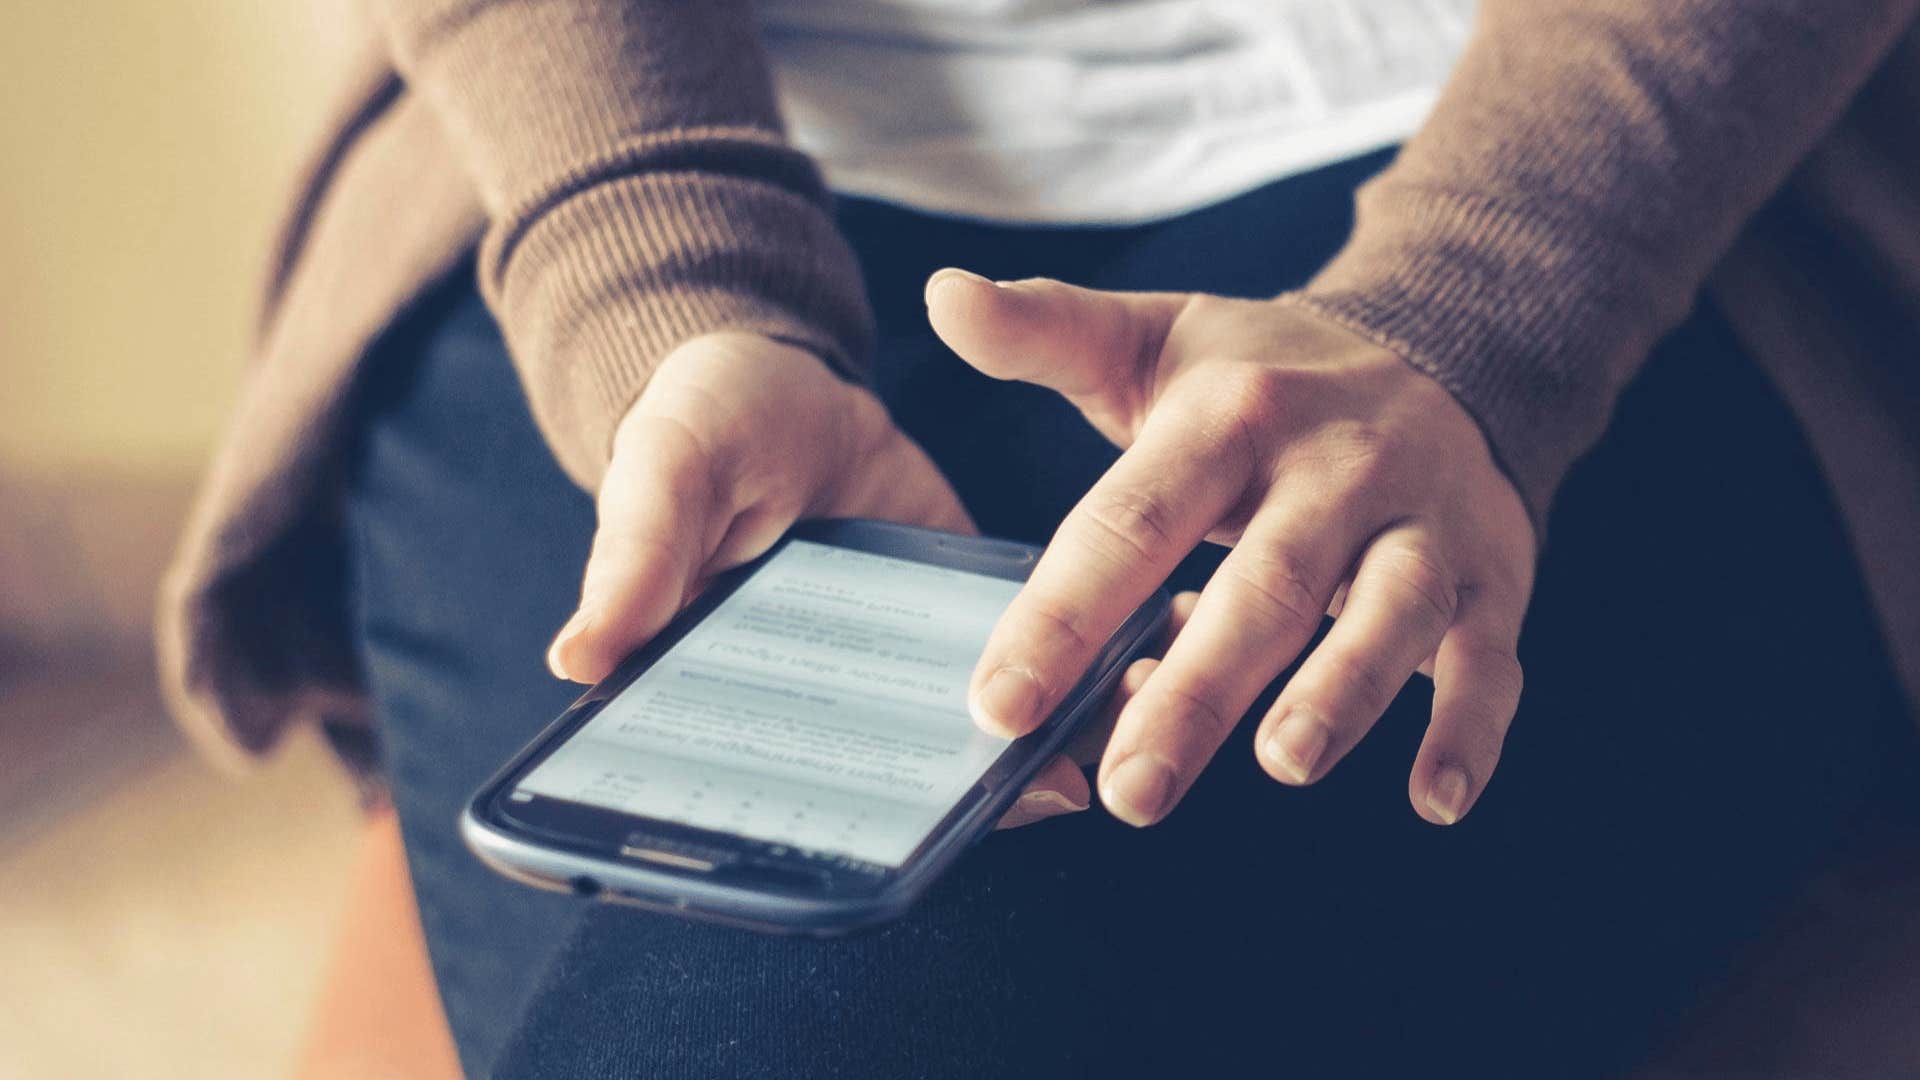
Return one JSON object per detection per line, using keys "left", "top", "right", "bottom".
{"left": 161, "top": 0, "right": 1920, "bottom": 1076}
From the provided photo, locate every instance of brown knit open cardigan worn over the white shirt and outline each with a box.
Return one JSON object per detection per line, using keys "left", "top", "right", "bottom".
{"left": 159, "top": 0, "right": 1920, "bottom": 761}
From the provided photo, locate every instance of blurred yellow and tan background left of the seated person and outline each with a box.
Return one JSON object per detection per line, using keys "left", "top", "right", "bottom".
{"left": 0, "top": 0, "right": 357, "bottom": 1078}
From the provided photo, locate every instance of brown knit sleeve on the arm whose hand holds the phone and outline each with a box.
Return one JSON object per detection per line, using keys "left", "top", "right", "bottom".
{"left": 364, "top": 0, "right": 872, "bottom": 490}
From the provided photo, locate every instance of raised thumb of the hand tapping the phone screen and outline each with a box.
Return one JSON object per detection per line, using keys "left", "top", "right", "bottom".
{"left": 927, "top": 267, "right": 1187, "bottom": 428}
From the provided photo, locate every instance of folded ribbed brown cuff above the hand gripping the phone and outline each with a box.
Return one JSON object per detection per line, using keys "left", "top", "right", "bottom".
{"left": 480, "top": 131, "right": 872, "bottom": 490}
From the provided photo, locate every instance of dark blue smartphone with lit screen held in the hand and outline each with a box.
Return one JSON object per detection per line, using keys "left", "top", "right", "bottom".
{"left": 461, "top": 521, "right": 1169, "bottom": 934}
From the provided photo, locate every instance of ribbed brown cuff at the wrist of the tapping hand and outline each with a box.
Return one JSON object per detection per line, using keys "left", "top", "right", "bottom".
{"left": 1281, "top": 190, "right": 1659, "bottom": 536}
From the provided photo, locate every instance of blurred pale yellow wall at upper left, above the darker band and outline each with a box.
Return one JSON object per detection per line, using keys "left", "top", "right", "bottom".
{"left": 0, "top": 0, "right": 353, "bottom": 475}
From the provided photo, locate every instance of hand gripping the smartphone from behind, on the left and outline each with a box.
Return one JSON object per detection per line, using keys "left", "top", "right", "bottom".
{"left": 547, "top": 332, "right": 1092, "bottom": 824}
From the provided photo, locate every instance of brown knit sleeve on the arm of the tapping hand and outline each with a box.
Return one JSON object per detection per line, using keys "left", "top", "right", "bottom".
{"left": 1284, "top": 0, "right": 1920, "bottom": 530}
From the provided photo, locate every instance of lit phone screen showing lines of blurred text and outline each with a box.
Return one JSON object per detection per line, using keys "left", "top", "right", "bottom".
{"left": 515, "top": 540, "right": 1020, "bottom": 867}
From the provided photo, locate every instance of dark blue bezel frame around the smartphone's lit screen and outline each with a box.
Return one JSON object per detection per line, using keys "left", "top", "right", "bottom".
{"left": 461, "top": 519, "right": 1169, "bottom": 934}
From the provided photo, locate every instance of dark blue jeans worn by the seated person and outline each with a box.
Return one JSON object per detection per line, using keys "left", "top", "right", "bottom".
{"left": 337, "top": 156, "right": 1914, "bottom": 1078}
